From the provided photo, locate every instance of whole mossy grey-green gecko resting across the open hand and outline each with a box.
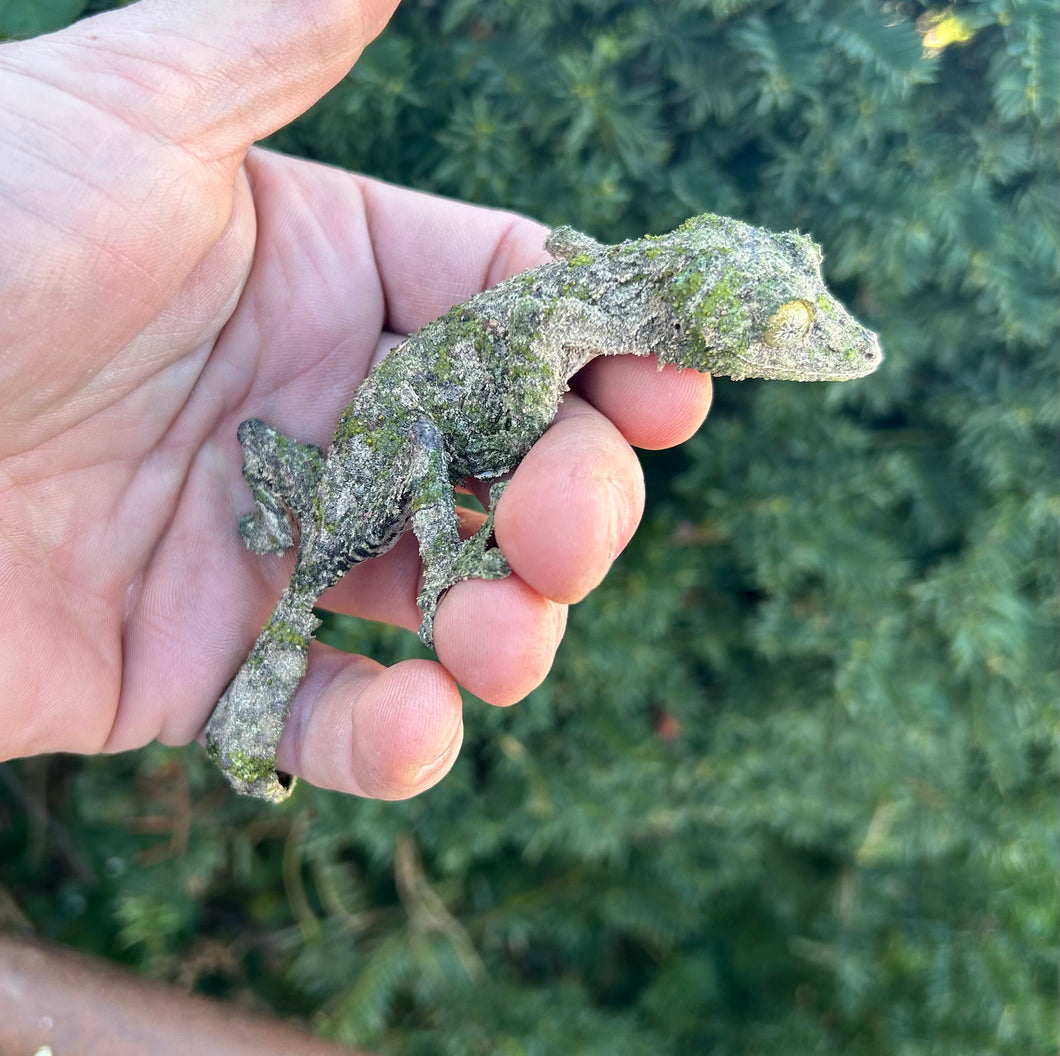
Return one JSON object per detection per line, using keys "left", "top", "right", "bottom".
{"left": 206, "top": 214, "right": 883, "bottom": 800}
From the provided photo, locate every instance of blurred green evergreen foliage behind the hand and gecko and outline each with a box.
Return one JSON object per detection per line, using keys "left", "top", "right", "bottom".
{"left": 0, "top": 0, "right": 1060, "bottom": 1056}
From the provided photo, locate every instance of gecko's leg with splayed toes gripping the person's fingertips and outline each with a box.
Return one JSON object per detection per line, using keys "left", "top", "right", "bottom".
{"left": 409, "top": 421, "right": 511, "bottom": 646}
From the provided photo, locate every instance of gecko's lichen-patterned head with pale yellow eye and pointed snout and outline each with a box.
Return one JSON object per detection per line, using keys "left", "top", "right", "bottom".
{"left": 672, "top": 216, "right": 883, "bottom": 382}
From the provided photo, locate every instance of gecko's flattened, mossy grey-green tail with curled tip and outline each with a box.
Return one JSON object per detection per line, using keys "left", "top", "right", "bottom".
{"left": 205, "top": 589, "right": 320, "bottom": 803}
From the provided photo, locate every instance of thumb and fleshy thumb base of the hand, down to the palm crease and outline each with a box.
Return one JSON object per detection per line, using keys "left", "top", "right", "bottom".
{"left": 0, "top": 0, "right": 398, "bottom": 451}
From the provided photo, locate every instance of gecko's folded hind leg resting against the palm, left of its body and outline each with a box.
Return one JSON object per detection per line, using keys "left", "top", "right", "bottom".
{"left": 236, "top": 418, "right": 324, "bottom": 553}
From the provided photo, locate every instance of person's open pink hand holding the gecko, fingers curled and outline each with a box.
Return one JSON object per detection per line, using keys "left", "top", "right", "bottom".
{"left": 0, "top": 0, "right": 710, "bottom": 798}
